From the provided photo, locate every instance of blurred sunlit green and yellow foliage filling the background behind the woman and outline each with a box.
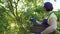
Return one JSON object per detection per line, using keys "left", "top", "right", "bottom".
{"left": 0, "top": 0, "right": 60, "bottom": 34}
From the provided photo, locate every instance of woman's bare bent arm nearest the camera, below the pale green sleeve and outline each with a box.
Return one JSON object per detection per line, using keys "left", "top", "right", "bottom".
{"left": 41, "top": 18, "right": 57, "bottom": 34}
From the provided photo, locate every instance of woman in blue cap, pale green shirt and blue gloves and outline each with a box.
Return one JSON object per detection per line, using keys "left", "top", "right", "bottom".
{"left": 31, "top": 2, "right": 57, "bottom": 34}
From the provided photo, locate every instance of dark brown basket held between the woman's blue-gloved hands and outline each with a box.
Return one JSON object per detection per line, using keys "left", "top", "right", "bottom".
{"left": 30, "top": 24, "right": 56, "bottom": 34}
